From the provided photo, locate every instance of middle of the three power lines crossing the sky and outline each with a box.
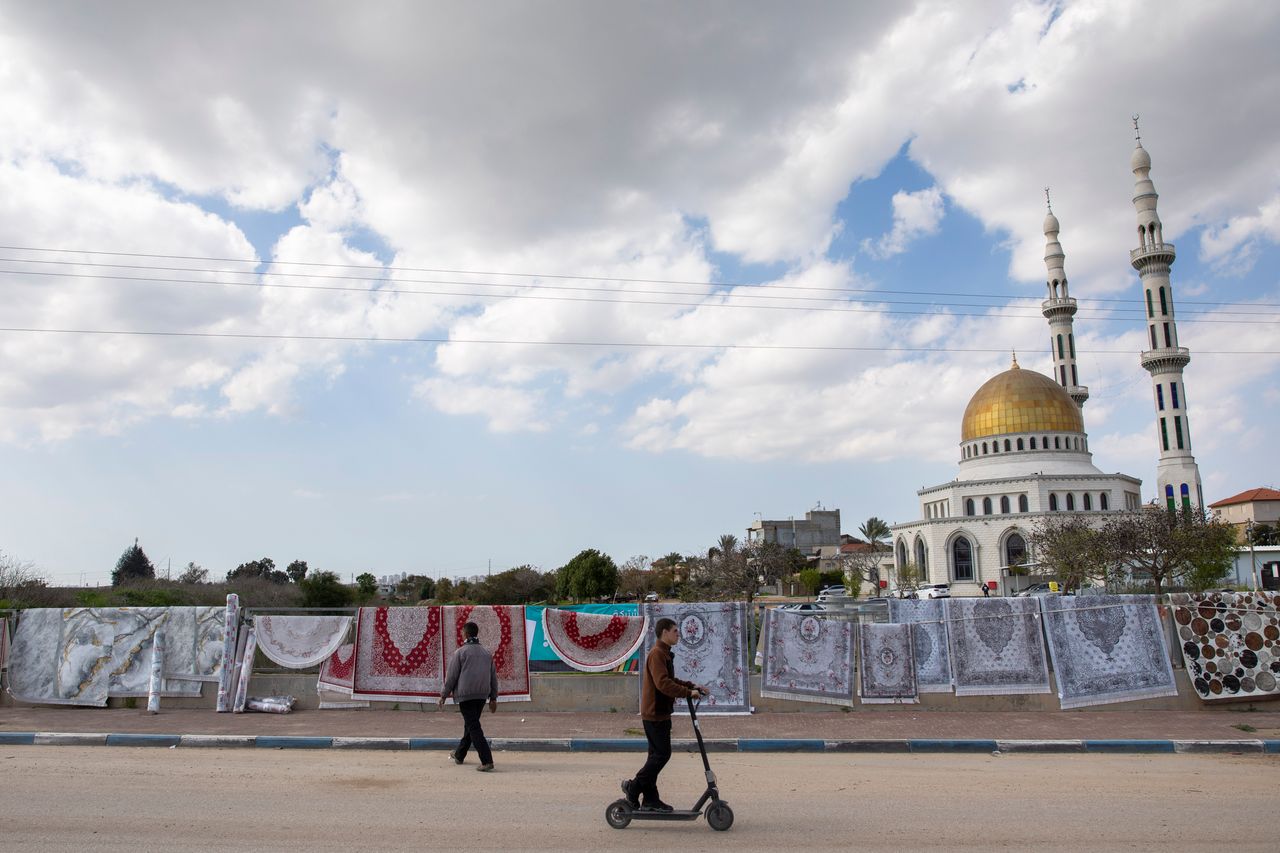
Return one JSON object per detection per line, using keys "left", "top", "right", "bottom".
{"left": 0, "top": 259, "right": 1280, "bottom": 325}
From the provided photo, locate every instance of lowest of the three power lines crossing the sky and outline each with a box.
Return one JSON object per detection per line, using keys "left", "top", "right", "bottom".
{"left": 0, "top": 327, "right": 1280, "bottom": 356}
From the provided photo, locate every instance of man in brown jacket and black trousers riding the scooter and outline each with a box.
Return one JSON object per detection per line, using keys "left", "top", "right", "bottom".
{"left": 622, "top": 619, "right": 707, "bottom": 812}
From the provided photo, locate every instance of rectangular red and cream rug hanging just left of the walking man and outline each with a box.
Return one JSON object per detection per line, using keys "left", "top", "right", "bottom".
{"left": 351, "top": 607, "right": 445, "bottom": 702}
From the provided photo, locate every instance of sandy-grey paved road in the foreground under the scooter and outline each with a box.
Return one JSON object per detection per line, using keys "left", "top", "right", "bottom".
{"left": 0, "top": 747, "right": 1280, "bottom": 853}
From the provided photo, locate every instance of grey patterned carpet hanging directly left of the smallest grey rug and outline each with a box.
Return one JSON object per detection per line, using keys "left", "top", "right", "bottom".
{"left": 752, "top": 607, "right": 854, "bottom": 704}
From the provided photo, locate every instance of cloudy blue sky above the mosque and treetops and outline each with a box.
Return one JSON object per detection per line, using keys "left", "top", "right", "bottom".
{"left": 0, "top": 0, "right": 1280, "bottom": 584}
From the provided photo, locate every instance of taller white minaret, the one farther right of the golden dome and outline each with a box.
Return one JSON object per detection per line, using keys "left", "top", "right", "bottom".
{"left": 1129, "top": 115, "right": 1204, "bottom": 510}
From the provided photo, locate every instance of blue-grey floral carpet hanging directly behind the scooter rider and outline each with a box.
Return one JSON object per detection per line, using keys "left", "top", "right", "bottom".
{"left": 637, "top": 602, "right": 751, "bottom": 713}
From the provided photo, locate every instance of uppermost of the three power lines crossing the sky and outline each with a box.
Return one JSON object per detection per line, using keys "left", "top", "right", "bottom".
{"left": 0, "top": 245, "right": 1280, "bottom": 307}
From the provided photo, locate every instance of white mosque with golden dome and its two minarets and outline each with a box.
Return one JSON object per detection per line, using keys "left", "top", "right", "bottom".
{"left": 891, "top": 126, "right": 1203, "bottom": 596}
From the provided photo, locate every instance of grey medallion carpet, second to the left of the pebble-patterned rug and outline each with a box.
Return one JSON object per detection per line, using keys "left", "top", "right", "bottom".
{"left": 943, "top": 597, "right": 1050, "bottom": 695}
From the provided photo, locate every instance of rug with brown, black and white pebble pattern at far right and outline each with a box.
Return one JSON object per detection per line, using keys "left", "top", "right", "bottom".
{"left": 1169, "top": 592, "right": 1280, "bottom": 702}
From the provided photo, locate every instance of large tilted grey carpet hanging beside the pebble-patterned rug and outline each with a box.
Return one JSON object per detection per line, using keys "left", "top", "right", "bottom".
{"left": 1041, "top": 596, "right": 1178, "bottom": 710}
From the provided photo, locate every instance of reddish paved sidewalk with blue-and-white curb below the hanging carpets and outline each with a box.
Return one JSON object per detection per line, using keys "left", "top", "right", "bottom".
{"left": 0, "top": 703, "right": 1280, "bottom": 753}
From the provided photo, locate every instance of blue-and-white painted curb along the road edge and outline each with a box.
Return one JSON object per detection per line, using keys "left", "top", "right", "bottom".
{"left": 0, "top": 731, "right": 1280, "bottom": 756}
